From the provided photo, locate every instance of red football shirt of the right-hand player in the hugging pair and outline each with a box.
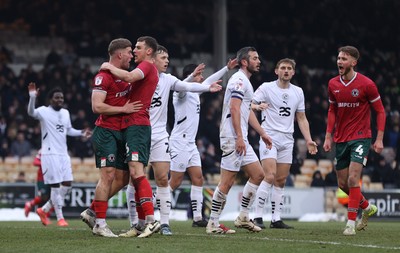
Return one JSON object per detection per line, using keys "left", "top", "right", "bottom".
{"left": 121, "top": 61, "right": 158, "bottom": 129}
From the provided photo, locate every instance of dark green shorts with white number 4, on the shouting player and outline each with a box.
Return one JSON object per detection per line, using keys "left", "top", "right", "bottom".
{"left": 336, "top": 138, "right": 371, "bottom": 170}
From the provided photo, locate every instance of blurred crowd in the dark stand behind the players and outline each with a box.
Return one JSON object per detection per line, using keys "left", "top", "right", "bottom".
{"left": 0, "top": 0, "right": 400, "bottom": 188}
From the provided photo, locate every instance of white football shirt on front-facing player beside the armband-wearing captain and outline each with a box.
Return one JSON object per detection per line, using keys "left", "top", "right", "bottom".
{"left": 253, "top": 80, "right": 305, "bottom": 133}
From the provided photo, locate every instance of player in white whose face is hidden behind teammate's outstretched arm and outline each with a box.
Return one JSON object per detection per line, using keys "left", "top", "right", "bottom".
{"left": 169, "top": 59, "right": 237, "bottom": 227}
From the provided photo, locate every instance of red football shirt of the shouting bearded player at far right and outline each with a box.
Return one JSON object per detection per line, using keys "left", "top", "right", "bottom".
{"left": 328, "top": 73, "right": 380, "bottom": 142}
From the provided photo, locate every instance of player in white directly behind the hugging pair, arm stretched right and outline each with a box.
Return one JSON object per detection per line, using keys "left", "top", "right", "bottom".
{"left": 123, "top": 45, "right": 222, "bottom": 235}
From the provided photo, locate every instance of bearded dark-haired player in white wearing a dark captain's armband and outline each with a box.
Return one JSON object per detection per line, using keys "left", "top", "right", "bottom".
{"left": 206, "top": 47, "right": 272, "bottom": 234}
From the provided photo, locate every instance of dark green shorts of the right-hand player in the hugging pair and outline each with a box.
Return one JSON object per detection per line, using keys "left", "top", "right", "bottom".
{"left": 122, "top": 126, "right": 151, "bottom": 166}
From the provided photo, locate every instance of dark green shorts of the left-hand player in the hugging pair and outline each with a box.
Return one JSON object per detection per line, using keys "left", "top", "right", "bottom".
{"left": 92, "top": 126, "right": 128, "bottom": 170}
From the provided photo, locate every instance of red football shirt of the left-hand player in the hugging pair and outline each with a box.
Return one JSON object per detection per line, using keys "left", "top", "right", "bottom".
{"left": 93, "top": 70, "right": 131, "bottom": 131}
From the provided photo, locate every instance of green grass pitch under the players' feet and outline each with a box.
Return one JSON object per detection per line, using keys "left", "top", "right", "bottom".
{"left": 0, "top": 219, "right": 400, "bottom": 253}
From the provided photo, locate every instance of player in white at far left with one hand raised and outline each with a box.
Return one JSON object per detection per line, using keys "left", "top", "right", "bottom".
{"left": 28, "top": 83, "right": 91, "bottom": 227}
